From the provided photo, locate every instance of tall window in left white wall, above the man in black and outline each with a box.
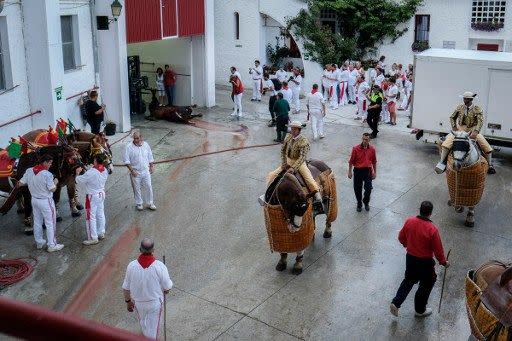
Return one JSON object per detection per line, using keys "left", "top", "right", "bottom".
{"left": 60, "top": 15, "right": 80, "bottom": 71}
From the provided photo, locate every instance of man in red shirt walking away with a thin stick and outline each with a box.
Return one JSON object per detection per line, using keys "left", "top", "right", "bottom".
{"left": 390, "top": 201, "right": 450, "bottom": 317}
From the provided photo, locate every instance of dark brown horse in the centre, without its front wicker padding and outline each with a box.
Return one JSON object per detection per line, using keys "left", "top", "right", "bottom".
{"left": 265, "top": 160, "right": 337, "bottom": 274}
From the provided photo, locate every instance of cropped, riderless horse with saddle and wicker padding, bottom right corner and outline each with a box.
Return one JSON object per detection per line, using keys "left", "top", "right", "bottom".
{"left": 466, "top": 261, "right": 512, "bottom": 341}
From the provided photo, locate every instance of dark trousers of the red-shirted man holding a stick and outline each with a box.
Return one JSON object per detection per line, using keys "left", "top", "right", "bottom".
{"left": 392, "top": 254, "right": 437, "bottom": 314}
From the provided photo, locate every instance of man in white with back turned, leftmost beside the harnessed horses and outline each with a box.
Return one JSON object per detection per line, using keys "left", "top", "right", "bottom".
{"left": 18, "top": 155, "right": 64, "bottom": 252}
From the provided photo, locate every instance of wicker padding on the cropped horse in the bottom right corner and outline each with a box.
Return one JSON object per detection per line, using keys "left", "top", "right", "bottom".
{"left": 466, "top": 270, "right": 512, "bottom": 341}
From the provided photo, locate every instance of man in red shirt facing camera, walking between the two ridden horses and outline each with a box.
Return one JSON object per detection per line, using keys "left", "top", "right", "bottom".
{"left": 348, "top": 133, "right": 377, "bottom": 212}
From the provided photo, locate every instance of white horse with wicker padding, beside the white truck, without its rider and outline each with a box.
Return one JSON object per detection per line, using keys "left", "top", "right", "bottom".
{"left": 446, "top": 131, "right": 488, "bottom": 227}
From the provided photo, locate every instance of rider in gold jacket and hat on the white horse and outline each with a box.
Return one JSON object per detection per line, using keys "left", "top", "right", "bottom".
{"left": 435, "top": 91, "right": 496, "bottom": 174}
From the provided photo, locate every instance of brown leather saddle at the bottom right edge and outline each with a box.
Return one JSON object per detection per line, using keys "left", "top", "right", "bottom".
{"left": 482, "top": 267, "right": 512, "bottom": 327}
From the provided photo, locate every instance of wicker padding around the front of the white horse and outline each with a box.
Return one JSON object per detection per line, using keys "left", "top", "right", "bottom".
{"left": 446, "top": 156, "right": 488, "bottom": 207}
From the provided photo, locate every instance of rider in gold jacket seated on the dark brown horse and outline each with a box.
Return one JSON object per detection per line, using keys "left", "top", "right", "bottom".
{"left": 267, "top": 121, "right": 325, "bottom": 214}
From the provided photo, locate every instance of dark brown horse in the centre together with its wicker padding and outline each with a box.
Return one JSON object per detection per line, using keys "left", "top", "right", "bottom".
{"left": 260, "top": 160, "right": 338, "bottom": 275}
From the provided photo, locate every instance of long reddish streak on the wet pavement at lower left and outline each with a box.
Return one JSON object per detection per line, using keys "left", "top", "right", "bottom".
{"left": 64, "top": 227, "right": 140, "bottom": 315}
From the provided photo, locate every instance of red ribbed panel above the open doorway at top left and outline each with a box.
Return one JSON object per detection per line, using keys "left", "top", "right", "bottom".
{"left": 125, "top": 0, "right": 205, "bottom": 44}
